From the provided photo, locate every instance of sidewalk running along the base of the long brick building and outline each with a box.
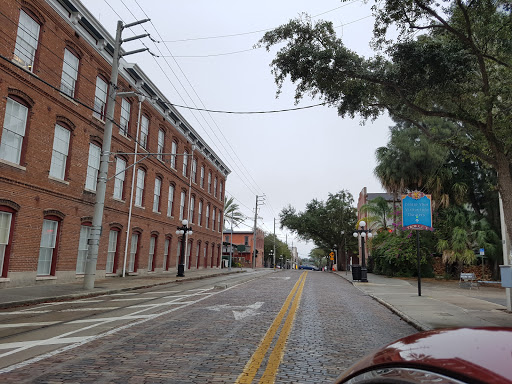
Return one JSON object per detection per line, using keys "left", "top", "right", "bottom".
{"left": 0, "top": 268, "right": 247, "bottom": 309}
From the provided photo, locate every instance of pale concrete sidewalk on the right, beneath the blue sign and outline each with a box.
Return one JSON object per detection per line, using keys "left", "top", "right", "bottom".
{"left": 335, "top": 271, "right": 512, "bottom": 330}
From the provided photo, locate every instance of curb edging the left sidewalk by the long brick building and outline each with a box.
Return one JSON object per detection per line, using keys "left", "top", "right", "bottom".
{"left": 0, "top": 270, "right": 246, "bottom": 309}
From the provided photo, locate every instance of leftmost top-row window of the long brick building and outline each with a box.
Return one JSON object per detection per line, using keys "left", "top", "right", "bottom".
{"left": 13, "top": 10, "right": 40, "bottom": 72}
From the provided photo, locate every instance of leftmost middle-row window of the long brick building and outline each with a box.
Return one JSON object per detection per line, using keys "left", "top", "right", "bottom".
{"left": 0, "top": 98, "right": 28, "bottom": 164}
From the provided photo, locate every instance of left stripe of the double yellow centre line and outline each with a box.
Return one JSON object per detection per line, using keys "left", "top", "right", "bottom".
{"left": 235, "top": 272, "right": 307, "bottom": 384}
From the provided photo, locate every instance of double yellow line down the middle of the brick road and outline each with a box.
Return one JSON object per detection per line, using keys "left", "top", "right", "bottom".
{"left": 235, "top": 272, "right": 307, "bottom": 384}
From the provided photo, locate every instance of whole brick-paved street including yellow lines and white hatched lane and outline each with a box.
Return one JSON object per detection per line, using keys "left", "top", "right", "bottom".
{"left": 0, "top": 270, "right": 416, "bottom": 383}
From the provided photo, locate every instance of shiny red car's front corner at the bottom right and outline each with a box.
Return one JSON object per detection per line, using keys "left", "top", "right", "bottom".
{"left": 336, "top": 328, "right": 512, "bottom": 384}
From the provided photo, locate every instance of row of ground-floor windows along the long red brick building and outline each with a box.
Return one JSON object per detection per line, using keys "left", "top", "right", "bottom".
{"left": 0, "top": 207, "right": 220, "bottom": 277}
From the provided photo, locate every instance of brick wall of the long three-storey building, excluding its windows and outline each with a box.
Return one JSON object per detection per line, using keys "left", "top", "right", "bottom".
{"left": 0, "top": 0, "right": 229, "bottom": 288}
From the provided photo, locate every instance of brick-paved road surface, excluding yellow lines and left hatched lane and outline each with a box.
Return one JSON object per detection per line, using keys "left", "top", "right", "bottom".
{"left": 0, "top": 270, "right": 415, "bottom": 383}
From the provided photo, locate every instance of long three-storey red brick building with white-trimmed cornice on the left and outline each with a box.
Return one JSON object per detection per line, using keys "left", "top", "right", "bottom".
{"left": 0, "top": 0, "right": 230, "bottom": 288}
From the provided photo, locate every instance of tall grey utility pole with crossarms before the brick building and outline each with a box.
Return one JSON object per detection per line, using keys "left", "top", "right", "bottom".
{"left": 84, "top": 19, "right": 149, "bottom": 290}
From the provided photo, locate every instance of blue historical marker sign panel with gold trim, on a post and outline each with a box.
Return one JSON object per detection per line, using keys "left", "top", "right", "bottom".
{"left": 402, "top": 191, "right": 434, "bottom": 231}
